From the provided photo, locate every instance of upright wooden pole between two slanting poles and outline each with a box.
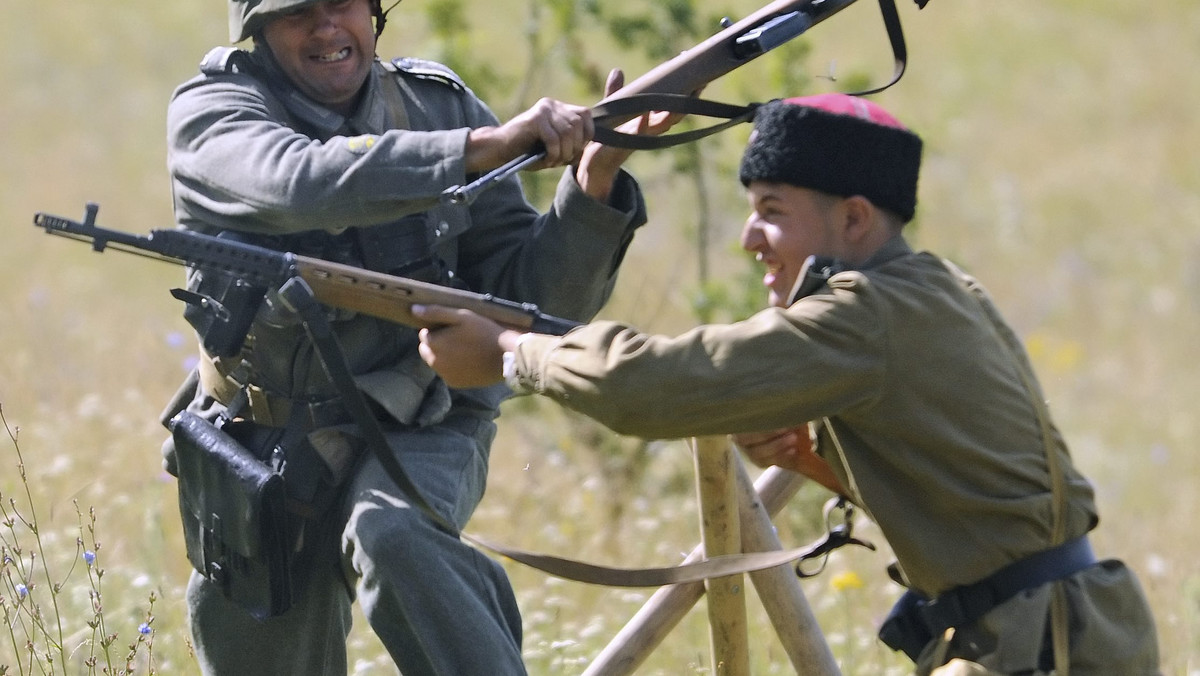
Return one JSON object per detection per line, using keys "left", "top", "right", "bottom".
{"left": 692, "top": 437, "right": 750, "bottom": 676}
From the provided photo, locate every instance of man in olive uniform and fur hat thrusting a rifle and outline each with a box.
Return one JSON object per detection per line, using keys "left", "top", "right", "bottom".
{"left": 418, "top": 95, "right": 1158, "bottom": 676}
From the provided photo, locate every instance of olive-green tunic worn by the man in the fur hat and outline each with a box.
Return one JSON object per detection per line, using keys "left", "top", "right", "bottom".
{"left": 512, "top": 238, "right": 1157, "bottom": 674}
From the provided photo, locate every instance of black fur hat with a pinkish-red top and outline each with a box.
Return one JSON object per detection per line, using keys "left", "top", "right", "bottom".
{"left": 739, "top": 94, "right": 922, "bottom": 222}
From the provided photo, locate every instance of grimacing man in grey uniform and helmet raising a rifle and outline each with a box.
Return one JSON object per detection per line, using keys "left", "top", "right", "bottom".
{"left": 164, "top": 0, "right": 674, "bottom": 676}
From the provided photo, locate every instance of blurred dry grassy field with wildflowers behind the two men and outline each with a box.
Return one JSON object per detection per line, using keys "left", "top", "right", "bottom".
{"left": 0, "top": 0, "right": 1200, "bottom": 676}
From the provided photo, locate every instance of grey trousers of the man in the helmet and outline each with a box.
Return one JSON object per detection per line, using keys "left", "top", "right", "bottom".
{"left": 187, "top": 414, "right": 526, "bottom": 676}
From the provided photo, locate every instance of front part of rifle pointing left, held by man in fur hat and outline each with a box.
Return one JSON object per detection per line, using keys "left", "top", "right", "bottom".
{"left": 34, "top": 204, "right": 578, "bottom": 354}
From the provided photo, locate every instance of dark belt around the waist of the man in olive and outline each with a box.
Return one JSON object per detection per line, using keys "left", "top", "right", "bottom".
{"left": 919, "top": 536, "right": 1096, "bottom": 636}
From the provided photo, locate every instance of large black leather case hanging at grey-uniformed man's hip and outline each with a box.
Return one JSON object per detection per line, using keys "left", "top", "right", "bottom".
{"left": 168, "top": 411, "right": 334, "bottom": 620}
